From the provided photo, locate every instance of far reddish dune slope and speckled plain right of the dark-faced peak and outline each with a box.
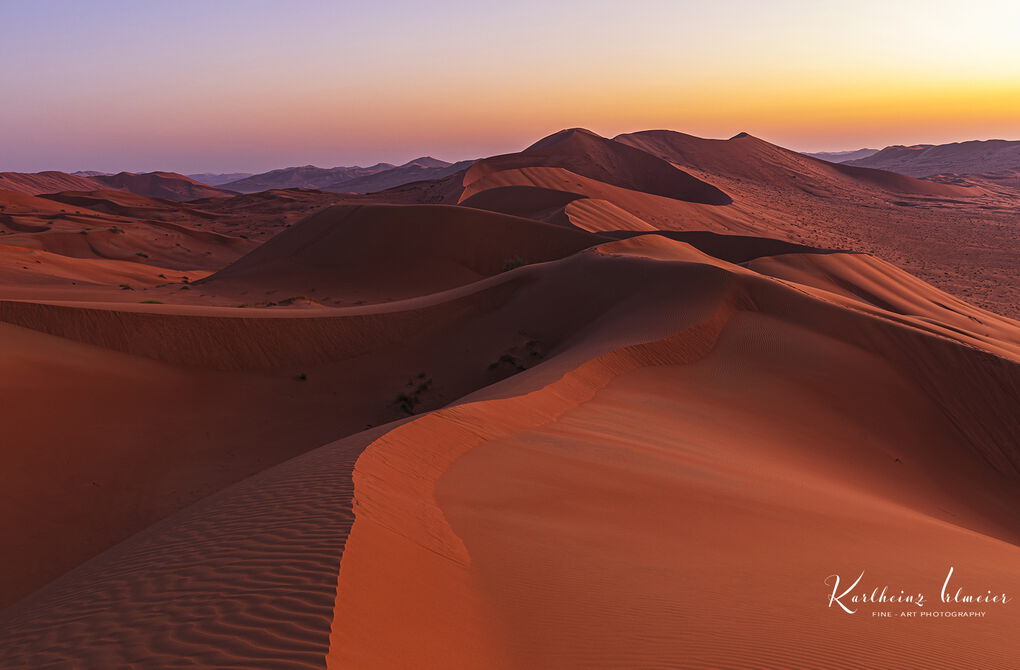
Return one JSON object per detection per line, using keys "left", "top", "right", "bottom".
{"left": 603, "top": 131, "right": 1020, "bottom": 317}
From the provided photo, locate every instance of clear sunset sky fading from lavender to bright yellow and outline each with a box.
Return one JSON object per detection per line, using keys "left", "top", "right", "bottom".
{"left": 0, "top": 0, "right": 1020, "bottom": 172}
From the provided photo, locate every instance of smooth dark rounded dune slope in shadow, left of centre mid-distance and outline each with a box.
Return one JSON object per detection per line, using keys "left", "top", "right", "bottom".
{"left": 203, "top": 205, "right": 601, "bottom": 302}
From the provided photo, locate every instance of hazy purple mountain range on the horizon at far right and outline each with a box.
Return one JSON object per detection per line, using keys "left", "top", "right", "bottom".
{"left": 847, "top": 140, "right": 1020, "bottom": 176}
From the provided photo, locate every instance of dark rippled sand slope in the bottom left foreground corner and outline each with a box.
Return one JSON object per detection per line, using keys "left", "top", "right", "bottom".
{"left": 0, "top": 420, "right": 385, "bottom": 669}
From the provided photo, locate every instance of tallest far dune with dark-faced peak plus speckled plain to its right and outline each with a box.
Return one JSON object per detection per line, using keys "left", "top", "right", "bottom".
{"left": 454, "top": 131, "right": 1020, "bottom": 316}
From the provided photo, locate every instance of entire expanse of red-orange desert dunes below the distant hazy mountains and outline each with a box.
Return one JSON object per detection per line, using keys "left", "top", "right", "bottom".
{"left": 0, "top": 128, "right": 1020, "bottom": 670}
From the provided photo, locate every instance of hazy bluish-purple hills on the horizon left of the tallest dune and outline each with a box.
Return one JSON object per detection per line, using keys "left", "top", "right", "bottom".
{"left": 219, "top": 156, "right": 473, "bottom": 193}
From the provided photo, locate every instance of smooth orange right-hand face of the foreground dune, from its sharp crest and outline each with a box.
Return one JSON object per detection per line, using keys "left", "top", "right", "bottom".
{"left": 328, "top": 247, "right": 1020, "bottom": 668}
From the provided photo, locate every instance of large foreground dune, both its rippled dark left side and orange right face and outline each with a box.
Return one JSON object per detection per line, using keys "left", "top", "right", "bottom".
{"left": 0, "top": 236, "right": 1020, "bottom": 668}
